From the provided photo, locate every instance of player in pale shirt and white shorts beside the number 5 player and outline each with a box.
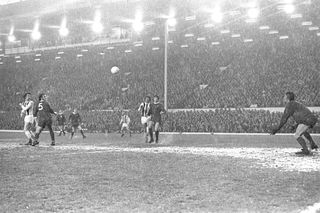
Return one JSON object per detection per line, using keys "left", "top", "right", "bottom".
{"left": 19, "top": 92, "right": 34, "bottom": 145}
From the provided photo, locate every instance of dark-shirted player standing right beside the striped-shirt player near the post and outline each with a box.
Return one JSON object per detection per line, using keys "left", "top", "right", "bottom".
{"left": 150, "top": 95, "right": 166, "bottom": 143}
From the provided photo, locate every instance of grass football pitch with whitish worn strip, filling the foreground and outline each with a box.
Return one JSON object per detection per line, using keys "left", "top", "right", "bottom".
{"left": 0, "top": 132, "right": 320, "bottom": 212}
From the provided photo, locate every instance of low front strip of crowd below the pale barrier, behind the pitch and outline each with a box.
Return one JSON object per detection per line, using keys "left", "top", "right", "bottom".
{"left": 0, "top": 109, "right": 320, "bottom": 133}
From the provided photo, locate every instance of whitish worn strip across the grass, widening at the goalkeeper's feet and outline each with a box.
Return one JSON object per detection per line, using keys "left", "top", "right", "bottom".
{"left": 0, "top": 143, "right": 320, "bottom": 172}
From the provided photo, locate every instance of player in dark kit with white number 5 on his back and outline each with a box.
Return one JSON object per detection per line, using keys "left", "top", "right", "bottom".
{"left": 32, "top": 93, "right": 56, "bottom": 146}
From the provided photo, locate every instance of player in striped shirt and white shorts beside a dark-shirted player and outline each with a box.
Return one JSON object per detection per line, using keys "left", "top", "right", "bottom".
{"left": 138, "top": 96, "right": 153, "bottom": 143}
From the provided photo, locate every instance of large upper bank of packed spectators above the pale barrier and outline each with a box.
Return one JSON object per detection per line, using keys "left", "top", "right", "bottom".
{"left": 0, "top": 31, "right": 320, "bottom": 111}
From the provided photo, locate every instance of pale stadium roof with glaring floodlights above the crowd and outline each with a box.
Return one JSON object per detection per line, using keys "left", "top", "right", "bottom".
{"left": 0, "top": 0, "right": 320, "bottom": 56}
